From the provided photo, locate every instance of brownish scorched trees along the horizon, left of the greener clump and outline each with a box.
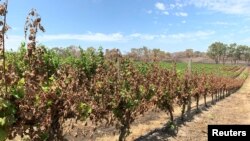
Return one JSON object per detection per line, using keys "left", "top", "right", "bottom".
{"left": 51, "top": 45, "right": 206, "bottom": 62}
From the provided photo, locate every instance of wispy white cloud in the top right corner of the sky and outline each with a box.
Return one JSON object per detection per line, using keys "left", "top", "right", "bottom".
{"left": 189, "top": 0, "right": 250, "bottom": 15}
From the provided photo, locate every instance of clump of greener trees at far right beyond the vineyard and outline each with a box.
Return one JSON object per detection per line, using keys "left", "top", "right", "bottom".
{"left": 207, "top": 42, "right": 250, "bottom": 64}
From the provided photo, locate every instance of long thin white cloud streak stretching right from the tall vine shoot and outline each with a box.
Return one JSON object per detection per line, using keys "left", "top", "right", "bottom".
{"left": 38, "top": 30, "right": 215, "bottom": 42}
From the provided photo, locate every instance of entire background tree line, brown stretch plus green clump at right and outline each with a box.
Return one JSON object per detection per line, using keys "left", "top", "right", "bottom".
{"left": 44, "top": 42, "right": 250, "bottom": 64}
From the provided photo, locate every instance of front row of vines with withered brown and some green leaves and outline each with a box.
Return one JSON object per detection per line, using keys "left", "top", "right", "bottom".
{"left": 0, "top": 1, "right": 247, "bottom": 141}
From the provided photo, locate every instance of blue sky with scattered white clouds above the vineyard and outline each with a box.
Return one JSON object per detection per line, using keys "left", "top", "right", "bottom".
{"left": 3, "top": 0, "right": 250, "bottom": 52}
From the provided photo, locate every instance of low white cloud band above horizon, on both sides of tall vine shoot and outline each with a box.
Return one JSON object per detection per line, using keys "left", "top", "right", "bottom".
{"left": 6, "top": 31, "right": 215, "bottom": 50}
